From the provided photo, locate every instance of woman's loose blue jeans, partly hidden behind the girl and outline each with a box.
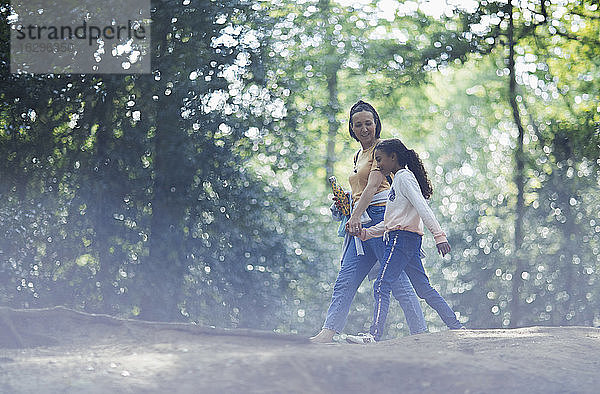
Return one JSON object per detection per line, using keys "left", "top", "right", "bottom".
{"left": 323, "top": 206, "right": 427, "bottom": 334}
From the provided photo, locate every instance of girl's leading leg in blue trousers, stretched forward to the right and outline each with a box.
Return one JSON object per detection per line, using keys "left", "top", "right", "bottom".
{"left": 404, "top": 256, "right": 463, "bottom": 330}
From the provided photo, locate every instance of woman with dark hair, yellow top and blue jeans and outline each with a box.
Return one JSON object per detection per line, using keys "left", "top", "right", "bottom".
{"left": 310, "top": 100, "right": 427, "bottom": 343}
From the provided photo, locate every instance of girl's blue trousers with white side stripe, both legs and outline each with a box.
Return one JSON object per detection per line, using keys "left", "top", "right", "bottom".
{"left": 370, "top": 230, "right": 462, "bottom": 341}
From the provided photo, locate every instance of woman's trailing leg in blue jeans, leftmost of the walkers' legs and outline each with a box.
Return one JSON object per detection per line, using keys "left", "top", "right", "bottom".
{"left": 323, "top": 238, "right": 375, "bottom": 332}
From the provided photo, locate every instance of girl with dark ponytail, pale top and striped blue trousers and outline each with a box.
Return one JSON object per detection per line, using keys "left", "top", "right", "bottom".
{"left": 347, "top": 139, "right": 464, "bottom": 343}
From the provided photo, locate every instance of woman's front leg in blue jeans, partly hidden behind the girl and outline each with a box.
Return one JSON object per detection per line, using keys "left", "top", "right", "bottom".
{"left": 366, "top": 229, "right": 427, "bottom": 334}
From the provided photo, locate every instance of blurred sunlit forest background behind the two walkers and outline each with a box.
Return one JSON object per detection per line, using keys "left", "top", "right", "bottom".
{"left": 0, "top": 0, "right": 600, "bottom": 337}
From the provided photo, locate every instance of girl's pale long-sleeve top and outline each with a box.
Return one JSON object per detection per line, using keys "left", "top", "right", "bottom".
{"left": 366, "top": 168, "right": 448, "bottom": 244}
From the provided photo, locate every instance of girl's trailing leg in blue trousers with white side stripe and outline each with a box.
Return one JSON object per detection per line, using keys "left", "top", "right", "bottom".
{"left": 370, "top": 231, "right": 415, "bottom": 341}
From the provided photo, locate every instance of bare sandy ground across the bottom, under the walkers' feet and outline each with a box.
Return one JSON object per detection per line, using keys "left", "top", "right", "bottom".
{"left": 0, "top": 307, "right": 600, "bottom": 394}
